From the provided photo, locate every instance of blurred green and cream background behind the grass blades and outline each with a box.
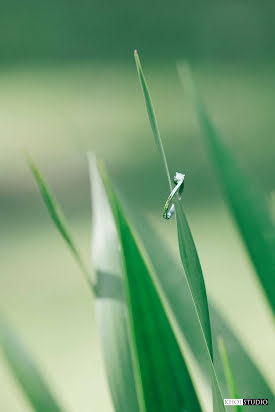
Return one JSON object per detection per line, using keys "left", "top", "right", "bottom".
{"left": 0, "top": 0, "right": 275, "bottom": 412}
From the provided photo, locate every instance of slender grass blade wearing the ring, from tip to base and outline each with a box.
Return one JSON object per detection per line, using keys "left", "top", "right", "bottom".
{"left": 135, "top": 52, "right": 225, "bottom": 412}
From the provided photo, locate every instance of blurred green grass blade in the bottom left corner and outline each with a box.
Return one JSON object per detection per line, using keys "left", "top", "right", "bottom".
{"left": 0, "top": 314, "right": 63, "bottom": 412}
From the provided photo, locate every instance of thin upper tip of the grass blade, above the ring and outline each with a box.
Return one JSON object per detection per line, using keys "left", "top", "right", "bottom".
{"left": 134, "top": 50, "right": 172, "bottom": 190}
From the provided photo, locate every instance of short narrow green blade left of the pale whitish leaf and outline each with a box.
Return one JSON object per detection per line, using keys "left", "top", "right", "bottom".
{"left": 26, "top": 154, "right": 92, "bottom": 286}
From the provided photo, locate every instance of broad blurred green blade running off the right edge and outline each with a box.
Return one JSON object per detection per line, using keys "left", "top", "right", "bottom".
{"left": 180, "top": 66, "right": 275, "bottom": 313}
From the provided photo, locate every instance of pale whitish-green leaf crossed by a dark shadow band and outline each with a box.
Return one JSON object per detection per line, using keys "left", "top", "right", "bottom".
{"left": 89, "top": 157, "right": 139, "bottom": 412}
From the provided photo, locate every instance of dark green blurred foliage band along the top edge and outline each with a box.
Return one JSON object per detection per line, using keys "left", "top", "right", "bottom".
{"left": 0, "top": 0, "right": 275, "bottom": 61}
